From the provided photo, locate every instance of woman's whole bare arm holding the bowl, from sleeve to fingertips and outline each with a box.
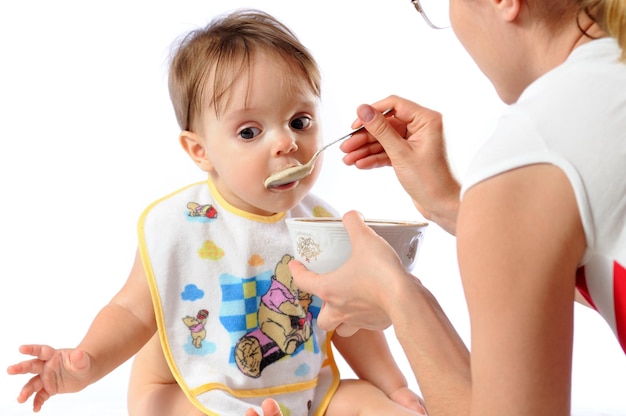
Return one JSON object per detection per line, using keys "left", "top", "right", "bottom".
{"left": 290, "top": 165, "right": 586, "bottom": 416}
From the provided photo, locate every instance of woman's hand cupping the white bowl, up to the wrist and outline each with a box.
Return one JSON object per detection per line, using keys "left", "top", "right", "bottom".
{"left": 289, "top": 211, "right": 413, "bottom": 336}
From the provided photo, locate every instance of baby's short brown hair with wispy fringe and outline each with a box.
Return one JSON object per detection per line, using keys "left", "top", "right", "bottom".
{"left": 169, "top": 9, "right": 321, "bottom": 130}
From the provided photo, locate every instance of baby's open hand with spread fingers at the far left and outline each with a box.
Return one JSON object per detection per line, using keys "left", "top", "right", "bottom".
{"left": 7, "top": 345, "right": 92, "bottom": 412}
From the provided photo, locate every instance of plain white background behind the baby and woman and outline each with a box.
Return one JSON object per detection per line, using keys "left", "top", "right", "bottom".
{"left": 0, "top": 0, "right": 626, "bottom": 416}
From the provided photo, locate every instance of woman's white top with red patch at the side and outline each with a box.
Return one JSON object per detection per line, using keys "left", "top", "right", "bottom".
{"left": 463, "top": 38, "right": 626, "bottom": 352}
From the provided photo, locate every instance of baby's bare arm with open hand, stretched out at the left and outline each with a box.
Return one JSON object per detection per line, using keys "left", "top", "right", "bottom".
{"left": 7, "top": 249, "right": 156, "bottom": 411}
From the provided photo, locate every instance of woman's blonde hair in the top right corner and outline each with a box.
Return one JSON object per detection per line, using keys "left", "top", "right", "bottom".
{"left": 582, "top": 0, "right": 626, "bottom": 62}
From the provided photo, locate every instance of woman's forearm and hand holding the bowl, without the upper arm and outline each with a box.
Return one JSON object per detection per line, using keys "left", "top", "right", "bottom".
{"left": 289, "top": 211, "right": 471, "bottom": 415}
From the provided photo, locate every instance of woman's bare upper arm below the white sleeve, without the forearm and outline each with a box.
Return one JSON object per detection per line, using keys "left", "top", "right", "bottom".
{"left": 450, "top": 164, "right": 586, "bottom": 416}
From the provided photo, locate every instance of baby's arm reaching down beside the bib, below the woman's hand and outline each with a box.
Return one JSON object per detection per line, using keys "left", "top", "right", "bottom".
{"left": 333, "top": 329, "right": 422, "bottom": 411}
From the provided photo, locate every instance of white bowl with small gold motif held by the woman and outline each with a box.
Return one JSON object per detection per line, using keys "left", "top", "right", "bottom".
{"left": 285, "top": 218, "right": 428, "bottom": 273}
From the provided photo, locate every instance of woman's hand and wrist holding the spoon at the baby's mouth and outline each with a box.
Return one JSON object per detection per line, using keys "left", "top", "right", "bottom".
{"left": 341, "top": 96, "right": 460, "bottom": 234}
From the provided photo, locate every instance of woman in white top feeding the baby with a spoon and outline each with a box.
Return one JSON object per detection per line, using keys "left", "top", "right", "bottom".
{"left": 286, "top": 0, "right": 626, "bottom": 416}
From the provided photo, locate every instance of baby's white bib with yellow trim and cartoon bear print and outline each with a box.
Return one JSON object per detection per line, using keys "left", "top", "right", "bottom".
{"left": 138, "top": 181, "right": 339, "bottom": 416}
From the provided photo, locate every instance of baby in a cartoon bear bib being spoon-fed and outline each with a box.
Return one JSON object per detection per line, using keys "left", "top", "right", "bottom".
{"left": 8, "top": 10, "right": 424, "bottom": 416}
